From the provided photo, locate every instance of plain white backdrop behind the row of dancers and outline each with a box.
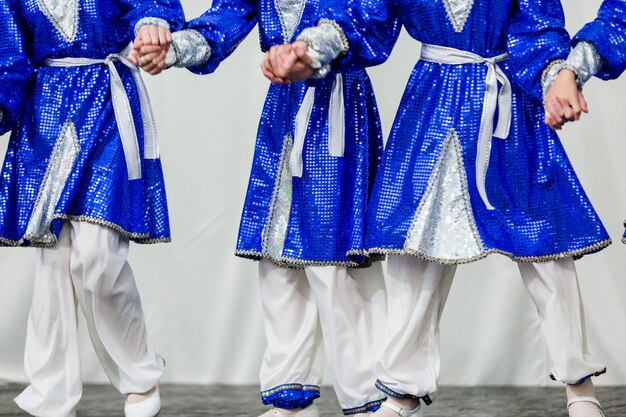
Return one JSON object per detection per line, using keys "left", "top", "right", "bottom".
{"left": 0, "top": 0, "right": 626, "bottom": 385}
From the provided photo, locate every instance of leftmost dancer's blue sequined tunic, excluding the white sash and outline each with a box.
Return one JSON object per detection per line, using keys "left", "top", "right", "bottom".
{"left": 0, "top": 0, "right": 184, "bottom": 246}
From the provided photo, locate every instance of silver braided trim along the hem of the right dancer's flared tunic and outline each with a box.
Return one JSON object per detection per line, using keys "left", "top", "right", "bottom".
{"left": 366, "top": 239, "right": 612, "bottom": 265}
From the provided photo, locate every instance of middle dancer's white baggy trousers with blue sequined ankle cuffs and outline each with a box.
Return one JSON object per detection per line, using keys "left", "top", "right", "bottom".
{"left": 259, "top": 260, "right": 387, "bottom": 414}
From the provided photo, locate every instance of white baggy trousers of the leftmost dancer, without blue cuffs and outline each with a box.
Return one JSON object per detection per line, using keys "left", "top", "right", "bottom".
{"left": 15, "top": 221, "right": 164, "bottom": 417}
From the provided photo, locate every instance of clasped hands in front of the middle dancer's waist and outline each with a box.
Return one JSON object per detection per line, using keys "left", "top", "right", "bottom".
{"left": 261, "top": 41, "right": 315, "bottom": 84}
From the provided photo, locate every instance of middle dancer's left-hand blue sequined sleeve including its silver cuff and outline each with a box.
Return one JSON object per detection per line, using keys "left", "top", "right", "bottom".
{"left": 174, "top": 0, "right": 258, "bottom": 74}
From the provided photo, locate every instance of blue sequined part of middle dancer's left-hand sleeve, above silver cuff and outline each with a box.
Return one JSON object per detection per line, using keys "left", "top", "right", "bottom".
{"left": 180, "top": 0, "right": 258, "bottom": 74}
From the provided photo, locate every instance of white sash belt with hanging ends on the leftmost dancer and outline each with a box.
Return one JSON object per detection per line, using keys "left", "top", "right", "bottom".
{"left": 45, "top": 48, "right": 159, "bottom": 180}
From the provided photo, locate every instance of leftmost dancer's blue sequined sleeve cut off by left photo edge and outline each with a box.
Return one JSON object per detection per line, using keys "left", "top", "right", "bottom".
{"left": 0, "top": 0, "right": 33, "bottom": 134}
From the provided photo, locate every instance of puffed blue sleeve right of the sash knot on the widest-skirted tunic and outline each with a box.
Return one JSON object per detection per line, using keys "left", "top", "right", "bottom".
{"left": 507, "top": 0, "right": 570, "bottom": 100}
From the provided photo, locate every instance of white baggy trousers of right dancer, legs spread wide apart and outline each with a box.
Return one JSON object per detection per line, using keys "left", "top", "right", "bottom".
{"left": 375, "top": 255, "right": 605, "bottom": 403}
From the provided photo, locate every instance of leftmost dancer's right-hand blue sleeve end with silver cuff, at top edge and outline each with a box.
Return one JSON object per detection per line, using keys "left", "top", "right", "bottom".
{"left": 122, "top": 0, "right": 185, "bottom": 35}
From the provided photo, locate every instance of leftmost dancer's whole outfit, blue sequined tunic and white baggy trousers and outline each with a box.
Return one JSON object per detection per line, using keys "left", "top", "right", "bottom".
{"left": 0, "top": 0, "right": 184, "bottom": 417}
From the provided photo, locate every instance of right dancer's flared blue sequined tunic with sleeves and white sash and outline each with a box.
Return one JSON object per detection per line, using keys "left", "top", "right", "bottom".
{"left": 328, "top": 0, "right": 610, "bottom": 263}
